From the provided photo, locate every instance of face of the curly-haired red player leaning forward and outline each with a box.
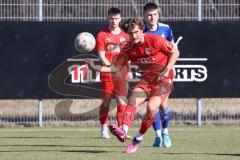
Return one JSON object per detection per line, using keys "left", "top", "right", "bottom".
{"left": 129, "top": 25, "right": 144, "bottom": 44}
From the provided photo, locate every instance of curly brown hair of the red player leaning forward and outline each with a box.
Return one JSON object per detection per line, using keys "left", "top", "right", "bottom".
{"left": 123, "top": 18, "right": 145, "bottom": 33}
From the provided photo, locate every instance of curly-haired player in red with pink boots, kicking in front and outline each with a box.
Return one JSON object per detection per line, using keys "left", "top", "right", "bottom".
{"left": 86, "top": 18, "right": 179, "bottom": 153}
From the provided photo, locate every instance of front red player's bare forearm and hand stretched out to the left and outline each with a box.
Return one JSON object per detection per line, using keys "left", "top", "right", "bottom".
{"left": 85, "top": 58, "right": 120, "bottom": 72}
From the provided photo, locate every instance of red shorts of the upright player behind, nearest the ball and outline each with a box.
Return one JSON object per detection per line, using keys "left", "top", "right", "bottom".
{"left": 101, "top": 80, "right": 128, "bottom": 99}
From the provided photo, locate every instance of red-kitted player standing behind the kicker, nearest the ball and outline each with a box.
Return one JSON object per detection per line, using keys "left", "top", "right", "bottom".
{"left": 96, "top": 8, "right": 130, "bottom": 138}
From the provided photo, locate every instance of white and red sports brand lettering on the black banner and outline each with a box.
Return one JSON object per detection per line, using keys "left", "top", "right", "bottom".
{"left": 68, "top": 58, "right": 207, "bottom": 84}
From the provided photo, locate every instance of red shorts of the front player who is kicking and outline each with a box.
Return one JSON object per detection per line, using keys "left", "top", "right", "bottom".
{"left": 134, "top": 79, "right": 173, "bottom": 101}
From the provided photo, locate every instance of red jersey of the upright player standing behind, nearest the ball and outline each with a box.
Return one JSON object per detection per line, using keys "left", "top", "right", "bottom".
{"left": 96, "top": 28, "right": 130, "bottom": 81}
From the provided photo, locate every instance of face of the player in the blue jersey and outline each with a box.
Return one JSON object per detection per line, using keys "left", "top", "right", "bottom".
{"left": 144, "top": 9, "right": 159, "bottom": 26}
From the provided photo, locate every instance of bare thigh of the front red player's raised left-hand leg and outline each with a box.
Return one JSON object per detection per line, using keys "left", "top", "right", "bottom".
{"left": 128, "top": 87, "right": 147, "bottom": 107}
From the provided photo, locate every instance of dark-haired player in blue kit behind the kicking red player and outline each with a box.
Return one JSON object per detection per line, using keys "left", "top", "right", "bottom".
{"left": 144, "top": 2, "right": 174, "bottom": 148}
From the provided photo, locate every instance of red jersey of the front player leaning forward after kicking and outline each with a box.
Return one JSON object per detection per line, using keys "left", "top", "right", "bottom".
{"left": 117, "top": 34, "right": 174, "bottom": 85}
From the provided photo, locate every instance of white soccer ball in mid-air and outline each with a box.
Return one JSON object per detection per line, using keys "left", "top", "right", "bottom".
{"left": 74, "top": 32, "right": 96, "bottom": 53}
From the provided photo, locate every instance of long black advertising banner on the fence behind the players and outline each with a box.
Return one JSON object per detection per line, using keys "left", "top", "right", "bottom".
{"left": 0, "top": 22, "right": 240, "bottom": 99}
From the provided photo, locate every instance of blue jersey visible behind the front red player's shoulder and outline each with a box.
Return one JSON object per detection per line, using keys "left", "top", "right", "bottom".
{"left": 144, "top": 23, "right": 173, "bottom": 41}
